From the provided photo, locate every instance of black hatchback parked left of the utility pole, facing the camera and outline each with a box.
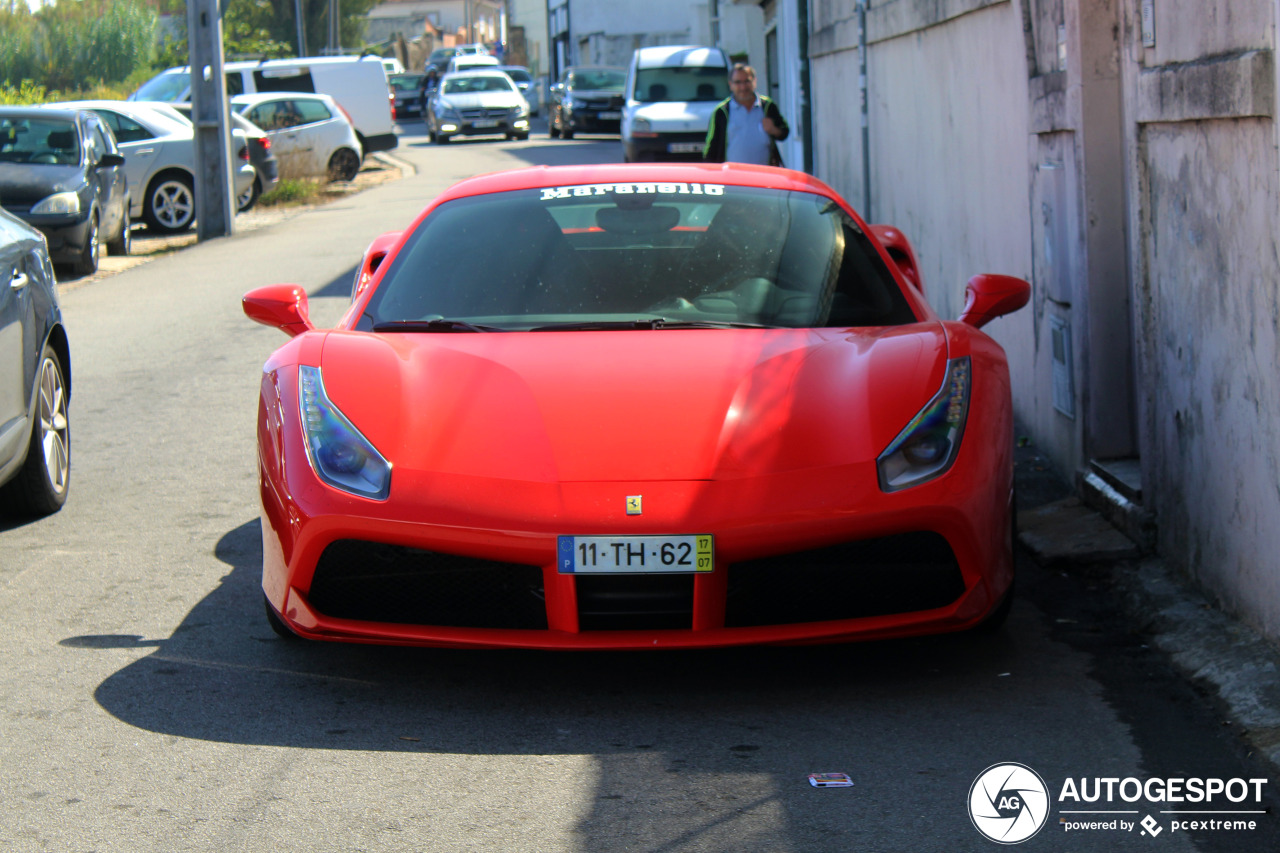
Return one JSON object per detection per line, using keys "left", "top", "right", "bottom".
{"left": 0, "top": 106, "right": 131, "bottom": 275}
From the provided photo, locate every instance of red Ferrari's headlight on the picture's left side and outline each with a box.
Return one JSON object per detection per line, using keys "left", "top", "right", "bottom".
{"left": 298, "top": 365, "right": 392, "bottom": 501}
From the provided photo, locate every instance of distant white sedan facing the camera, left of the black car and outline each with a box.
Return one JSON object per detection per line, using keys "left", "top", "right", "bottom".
{"left": 426, "top": 70, "right": 529, "bottom": 145}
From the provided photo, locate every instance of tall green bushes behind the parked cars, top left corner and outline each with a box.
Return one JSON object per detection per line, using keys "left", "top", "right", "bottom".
{"left": 0, "top": 0, "right": 156, "bottom": 90}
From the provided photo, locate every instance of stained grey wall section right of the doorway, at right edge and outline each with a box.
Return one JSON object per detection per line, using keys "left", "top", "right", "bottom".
{"left": 1124, "top": 0, "right": 1280, "bottom": 638}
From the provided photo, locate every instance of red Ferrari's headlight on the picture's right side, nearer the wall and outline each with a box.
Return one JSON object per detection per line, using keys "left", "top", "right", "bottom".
{"left": 876, "top": 356, "right": 970, "bottom": 492}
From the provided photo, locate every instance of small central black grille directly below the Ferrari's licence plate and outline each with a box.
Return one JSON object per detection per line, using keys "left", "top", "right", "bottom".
{"left": 575, "top": 575, "right": 694, "bottom": 631}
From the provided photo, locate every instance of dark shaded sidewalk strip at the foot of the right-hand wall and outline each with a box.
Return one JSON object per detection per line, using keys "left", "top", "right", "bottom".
{"left": 1018, "top": 447, "right": 1280, "bottom": 772}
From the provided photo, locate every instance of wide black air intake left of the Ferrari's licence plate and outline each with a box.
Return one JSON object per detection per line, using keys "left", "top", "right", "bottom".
{"left": 307, "top": 539, "right": 547, "bottom": 630}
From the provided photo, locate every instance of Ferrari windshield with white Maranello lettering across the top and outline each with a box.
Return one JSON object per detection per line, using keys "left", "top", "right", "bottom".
{"left": 358, "top": 183, "right": 916, "bottom": 332}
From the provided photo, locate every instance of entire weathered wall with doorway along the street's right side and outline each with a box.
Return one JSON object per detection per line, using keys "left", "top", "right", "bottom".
{"left": 803, "top": 0, "right": 1280, "bottom": 639}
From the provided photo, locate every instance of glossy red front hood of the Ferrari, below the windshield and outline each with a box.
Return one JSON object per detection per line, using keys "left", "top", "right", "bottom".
{"left": 320, "top": 323, "right": 947, "bottom": 483}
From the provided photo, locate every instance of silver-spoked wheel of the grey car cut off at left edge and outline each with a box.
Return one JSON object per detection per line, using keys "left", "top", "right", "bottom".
{"left": 0, "top": 343, "right": 72, "bottom": 515}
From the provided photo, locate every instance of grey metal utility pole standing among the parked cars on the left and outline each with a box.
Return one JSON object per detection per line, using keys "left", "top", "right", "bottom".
{"left": 187, "top": 0, "right": 236, "bottom": 236}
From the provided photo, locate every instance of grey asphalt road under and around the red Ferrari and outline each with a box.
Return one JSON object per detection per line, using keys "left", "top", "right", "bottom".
{"left": 0, "top": 116, "right": 1280, "bottom": 853}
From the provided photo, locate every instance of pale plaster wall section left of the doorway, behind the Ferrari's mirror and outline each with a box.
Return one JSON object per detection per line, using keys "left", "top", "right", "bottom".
{"left": 809, "top": 0, "right": 1036, "bottom": 405}
